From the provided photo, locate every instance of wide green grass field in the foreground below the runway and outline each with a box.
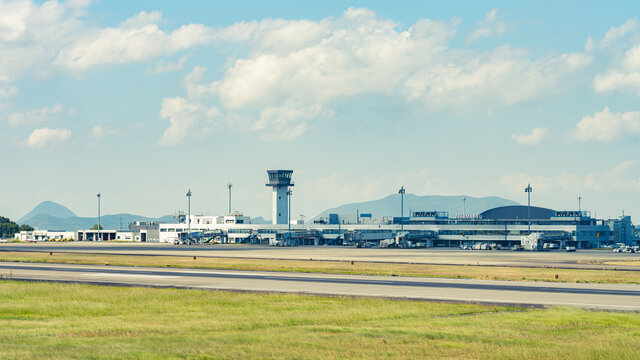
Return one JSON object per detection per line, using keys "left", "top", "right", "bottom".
{"left": 0, "top": 281, "right": 640, "bottom": 359}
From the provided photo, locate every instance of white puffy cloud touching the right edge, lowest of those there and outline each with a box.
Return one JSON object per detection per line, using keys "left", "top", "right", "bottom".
{"left": 573, "top": 107, "right": 640, "bottom": 142}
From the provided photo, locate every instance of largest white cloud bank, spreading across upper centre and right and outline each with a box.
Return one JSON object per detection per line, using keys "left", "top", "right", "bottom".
{"left": 159, "top": 8, "right": 592, "bottom": 143}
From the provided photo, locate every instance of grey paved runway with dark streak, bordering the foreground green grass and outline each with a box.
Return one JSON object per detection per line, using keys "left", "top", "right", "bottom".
{"left": 0, "top": 262, "right": 640, "bottom": 311}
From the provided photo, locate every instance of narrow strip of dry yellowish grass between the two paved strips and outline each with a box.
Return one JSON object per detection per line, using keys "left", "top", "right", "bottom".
{"left": 0, "top": 252, "right": 640, "bottom": 284}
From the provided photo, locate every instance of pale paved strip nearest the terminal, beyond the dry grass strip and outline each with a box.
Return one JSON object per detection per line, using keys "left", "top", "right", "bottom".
{"left": 0, "top": 242, "right": 640, "bottom": 270}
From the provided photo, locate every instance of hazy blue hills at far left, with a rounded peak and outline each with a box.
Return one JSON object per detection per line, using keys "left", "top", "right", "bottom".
{"left": 17, "top": 201, "right": 175, "bottom": 231}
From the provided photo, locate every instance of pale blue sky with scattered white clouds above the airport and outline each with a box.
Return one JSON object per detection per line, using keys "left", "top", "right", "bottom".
{"left": 0, "top": 0, "right": 640, "bottom": 222}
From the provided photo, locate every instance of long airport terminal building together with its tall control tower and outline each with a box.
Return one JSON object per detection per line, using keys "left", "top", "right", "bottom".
{"left": 159, "top": 170, "right": 638, "bottom": 248}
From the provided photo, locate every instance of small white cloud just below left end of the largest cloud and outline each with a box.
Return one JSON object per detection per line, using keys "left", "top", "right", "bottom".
{"left": 159, "top": 97, "right": 220, "bottom": 145}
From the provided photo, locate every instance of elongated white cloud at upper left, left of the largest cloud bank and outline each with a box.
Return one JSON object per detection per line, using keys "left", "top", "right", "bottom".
{"left": 55, "top": 11, "right": 213, "bottom": 70}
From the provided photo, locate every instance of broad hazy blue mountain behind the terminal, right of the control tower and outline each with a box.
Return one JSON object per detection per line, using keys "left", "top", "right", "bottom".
{"left": 314, "top": 194, "right": 519, "bottom": 220}
